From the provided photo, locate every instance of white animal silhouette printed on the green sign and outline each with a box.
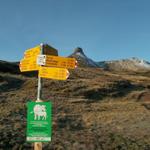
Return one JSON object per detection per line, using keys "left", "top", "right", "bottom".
{"left": 33, "top": 104, "right": 47, "bottom": 120}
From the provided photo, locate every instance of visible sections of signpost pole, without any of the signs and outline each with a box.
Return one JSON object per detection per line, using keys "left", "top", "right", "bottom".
{"left": 34, "top": 43, "right": 44, "bottom": 150}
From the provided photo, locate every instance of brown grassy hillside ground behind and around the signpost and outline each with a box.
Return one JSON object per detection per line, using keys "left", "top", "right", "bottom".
{"left": 0, "top": 68, "right": 150, "bottom": 150}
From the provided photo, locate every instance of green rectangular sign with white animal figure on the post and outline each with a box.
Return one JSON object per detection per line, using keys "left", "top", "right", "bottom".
{"left": 27, "top": 102, "right": 52, "bottom": 142}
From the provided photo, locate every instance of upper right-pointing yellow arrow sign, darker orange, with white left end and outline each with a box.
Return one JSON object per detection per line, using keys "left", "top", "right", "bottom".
{"left": 38, "top": 55, "right": 77, "bottom": 69}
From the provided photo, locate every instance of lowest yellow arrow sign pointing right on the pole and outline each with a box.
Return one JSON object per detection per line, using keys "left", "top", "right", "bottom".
{"left": 39, "top": 67, "right": 69, "bottom": 80}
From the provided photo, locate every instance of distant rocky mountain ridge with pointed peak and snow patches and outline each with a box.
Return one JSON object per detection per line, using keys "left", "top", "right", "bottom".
{"left": 69, "top": 47, "right": 150, "bottom": 71}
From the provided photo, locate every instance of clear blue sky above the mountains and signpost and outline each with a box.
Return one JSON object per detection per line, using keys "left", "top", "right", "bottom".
{"left": 0, "top": 0, "right": 150, "bottom": 61}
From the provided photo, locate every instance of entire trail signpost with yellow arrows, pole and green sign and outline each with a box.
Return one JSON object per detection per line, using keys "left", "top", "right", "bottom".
{"left": 19, "top": 44, "right": 77, "bottom": 150}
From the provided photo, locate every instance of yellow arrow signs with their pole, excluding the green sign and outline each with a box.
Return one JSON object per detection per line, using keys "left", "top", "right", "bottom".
{"left": 19, "top": 44, "right": 77, "bottom": 150}
